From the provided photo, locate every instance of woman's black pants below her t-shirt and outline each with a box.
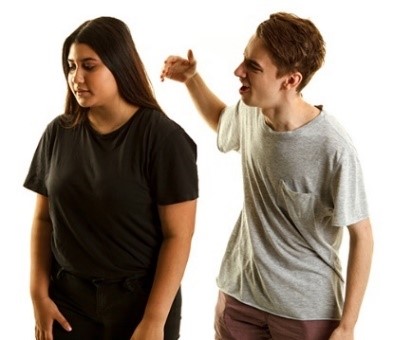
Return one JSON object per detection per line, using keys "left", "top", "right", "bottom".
{"left": 50, "top": 269, "right": 182, "bottom": 340}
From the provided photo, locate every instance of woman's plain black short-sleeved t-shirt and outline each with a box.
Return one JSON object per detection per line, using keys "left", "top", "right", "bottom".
{"left": 24, "top": 108, "right": 198, "bottom": 278}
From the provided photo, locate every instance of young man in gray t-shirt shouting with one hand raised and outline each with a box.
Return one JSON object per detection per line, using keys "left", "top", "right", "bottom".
{"left": 161, "top": 13, "right": 373, "bottom": 340}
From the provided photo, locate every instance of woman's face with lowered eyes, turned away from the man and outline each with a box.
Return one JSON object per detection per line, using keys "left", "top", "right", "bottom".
{"left": 68, "top": 43, "right": 120, "bottom": 108}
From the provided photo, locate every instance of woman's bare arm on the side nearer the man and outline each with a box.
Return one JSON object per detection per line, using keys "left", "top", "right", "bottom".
{"left": 131, "top": 200, "right": 196, "bottom": 340}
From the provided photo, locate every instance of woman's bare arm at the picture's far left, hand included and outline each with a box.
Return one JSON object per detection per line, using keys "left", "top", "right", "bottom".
{"left": 30, "top": 195, "right": 71, "bottom": 340}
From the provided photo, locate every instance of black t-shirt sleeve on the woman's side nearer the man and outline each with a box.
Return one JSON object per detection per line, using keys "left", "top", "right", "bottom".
{"left": 152, "top": 127, "right": 198, "bottom": 205}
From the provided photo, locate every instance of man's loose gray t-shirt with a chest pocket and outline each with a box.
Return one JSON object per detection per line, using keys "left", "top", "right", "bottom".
{"left": 217, "top": 102, "right": 368, "bottom": 320}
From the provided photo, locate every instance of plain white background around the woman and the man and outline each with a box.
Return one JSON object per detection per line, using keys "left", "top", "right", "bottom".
{"left": 0, "top": 0, "right": 393, "bottom": 340}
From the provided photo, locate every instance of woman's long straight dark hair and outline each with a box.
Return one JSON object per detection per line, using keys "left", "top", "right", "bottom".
{"left": 62, "top": 17, "right": 163, "bottom": 126}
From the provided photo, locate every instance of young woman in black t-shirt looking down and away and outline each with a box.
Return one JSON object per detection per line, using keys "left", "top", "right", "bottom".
{"left": 24, "top": 17, "right": 198, "bottom": 340}
